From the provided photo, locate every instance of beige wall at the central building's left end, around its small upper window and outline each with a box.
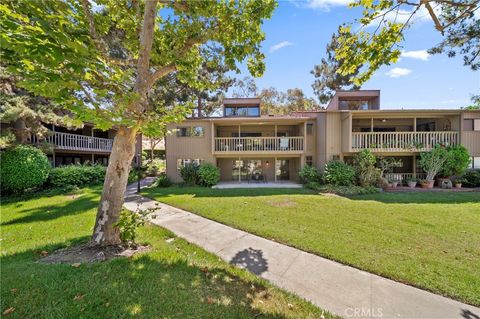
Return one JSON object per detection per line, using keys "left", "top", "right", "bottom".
{"left": 165, "top": 120, "right": 215, "bottom": 183}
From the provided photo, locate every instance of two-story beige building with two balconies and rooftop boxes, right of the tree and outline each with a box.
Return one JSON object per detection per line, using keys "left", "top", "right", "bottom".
{"left": 166, "top": 90, "right": 480, "bottom": 182}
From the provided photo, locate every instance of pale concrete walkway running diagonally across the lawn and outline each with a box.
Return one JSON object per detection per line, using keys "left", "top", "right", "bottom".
{"left": 125, "top": 181, "right": 480, "bottom": 319}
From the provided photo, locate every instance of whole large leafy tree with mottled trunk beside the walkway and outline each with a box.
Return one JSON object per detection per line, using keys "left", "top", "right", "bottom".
{"left": 0, "top": 0, "right": 276, "bottom": 245}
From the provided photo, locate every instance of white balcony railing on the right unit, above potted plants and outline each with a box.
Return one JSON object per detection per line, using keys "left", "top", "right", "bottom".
{"left": 351, "top": 131, "right": 458, "bottom": 152}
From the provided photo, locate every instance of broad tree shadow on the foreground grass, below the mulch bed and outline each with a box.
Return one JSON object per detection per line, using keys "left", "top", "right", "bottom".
{"left": 1, "top": 246, "right": 314, "bottom": 318}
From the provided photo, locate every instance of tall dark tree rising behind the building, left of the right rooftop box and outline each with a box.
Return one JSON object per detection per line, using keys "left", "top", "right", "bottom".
{"left": 311, "top": 34, "right": 360, "bottom": 104}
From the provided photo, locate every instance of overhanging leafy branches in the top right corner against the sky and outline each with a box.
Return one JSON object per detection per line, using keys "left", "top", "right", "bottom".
{"left": 335, "top": 0, "right": 480, "bottom": 85}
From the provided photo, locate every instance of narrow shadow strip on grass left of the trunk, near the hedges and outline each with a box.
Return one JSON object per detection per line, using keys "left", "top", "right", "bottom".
{"left": 0, "top": 193, "right": 98, "bottom": 226}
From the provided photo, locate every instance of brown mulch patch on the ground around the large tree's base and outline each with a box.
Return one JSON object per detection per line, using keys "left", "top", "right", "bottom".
{"left": 39, "top": 243, "right": 150, "bottom": 266}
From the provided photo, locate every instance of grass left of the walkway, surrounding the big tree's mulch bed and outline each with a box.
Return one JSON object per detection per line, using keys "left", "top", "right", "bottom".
{"left": 0, "top": 188, "right": 329, "bottom": 318}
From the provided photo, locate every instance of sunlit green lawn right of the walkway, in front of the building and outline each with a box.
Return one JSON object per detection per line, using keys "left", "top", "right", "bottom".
{"left": 144, "top": 187, "right": 480, "bottom": 305}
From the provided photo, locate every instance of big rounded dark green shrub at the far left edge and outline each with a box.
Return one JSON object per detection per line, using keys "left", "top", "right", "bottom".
{"left": 0, "top": 145, "right": 51, "bottom": 193}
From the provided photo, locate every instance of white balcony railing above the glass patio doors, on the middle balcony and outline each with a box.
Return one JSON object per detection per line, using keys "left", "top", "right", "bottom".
{"left": 215, "top": 136, "right": 303, "bottom": 153}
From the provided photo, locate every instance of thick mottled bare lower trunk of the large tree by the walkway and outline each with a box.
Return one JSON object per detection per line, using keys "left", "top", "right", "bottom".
{"left": 92, "top": 127, "right": 137, "bottom": 246}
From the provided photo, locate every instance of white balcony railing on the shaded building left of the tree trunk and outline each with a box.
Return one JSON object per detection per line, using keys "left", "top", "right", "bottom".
{"left": 38, "top": 132, "right": 113, "bottom": 152}
